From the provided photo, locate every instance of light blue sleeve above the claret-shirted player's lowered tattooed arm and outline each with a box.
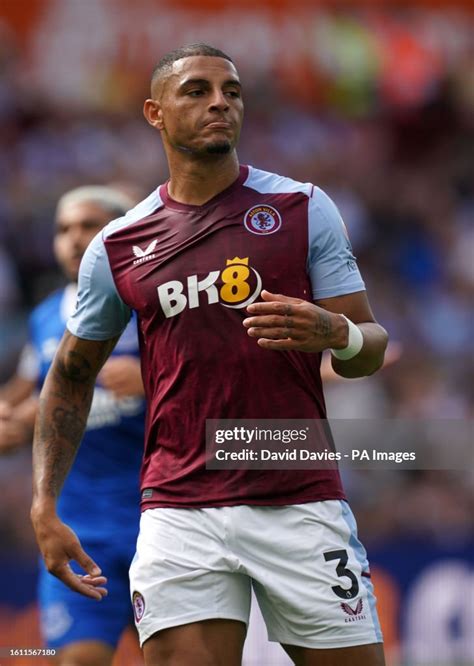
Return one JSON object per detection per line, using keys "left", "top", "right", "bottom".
{"left": 66, "top": 232, "right": 131, "bottom": 340}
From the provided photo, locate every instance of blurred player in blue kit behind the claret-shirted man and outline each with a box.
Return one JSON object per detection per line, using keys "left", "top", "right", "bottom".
{"left": 0, "top": 186, "right": 145, "bottom": 666}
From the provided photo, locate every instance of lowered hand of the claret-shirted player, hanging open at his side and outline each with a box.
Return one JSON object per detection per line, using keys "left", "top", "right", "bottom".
{"left": 31, "top": 507, "right": 107, "bottom": 601}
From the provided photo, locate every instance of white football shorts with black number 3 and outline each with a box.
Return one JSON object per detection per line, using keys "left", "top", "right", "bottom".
{"left": 130, "top": 500, "right": 382, "bottom": 649}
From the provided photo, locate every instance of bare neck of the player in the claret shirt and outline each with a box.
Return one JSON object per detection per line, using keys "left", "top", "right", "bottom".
{"left": 168, "top": 151, "right": 239, "bottom": 206}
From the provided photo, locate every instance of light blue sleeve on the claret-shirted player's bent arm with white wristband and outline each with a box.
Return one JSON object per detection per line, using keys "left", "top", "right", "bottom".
{"left": 307, "top": 187, "right": 365, "bottom": 300}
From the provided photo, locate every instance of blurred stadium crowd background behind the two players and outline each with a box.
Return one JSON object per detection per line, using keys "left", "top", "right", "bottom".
{"left": 0, "top": 0, "right": 474, "bottom": 666}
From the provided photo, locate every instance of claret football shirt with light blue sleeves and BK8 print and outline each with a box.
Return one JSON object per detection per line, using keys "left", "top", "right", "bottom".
{"left": 68, "top": 166, "right": 365, "bottom": 509}
